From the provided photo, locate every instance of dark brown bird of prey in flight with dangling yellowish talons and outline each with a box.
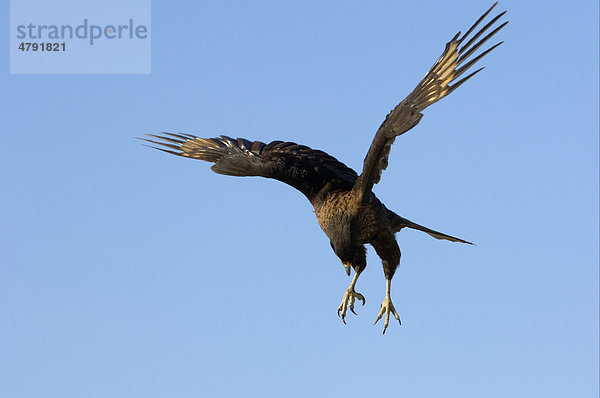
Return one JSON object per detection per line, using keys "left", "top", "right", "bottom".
{"left": 142, "top": 2, "right": 508, "bottom": 333}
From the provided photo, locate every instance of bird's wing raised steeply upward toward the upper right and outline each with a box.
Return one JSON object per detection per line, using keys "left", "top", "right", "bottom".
{"left": 353, "top": 2, "right": 508, "bottom": 198}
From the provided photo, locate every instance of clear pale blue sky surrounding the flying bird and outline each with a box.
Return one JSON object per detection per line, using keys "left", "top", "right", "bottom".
{"left": 0, "top": 0, "right": 599, "bottom": 398}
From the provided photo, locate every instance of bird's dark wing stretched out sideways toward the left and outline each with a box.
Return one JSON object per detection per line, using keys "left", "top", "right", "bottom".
{"left": 140, "top": 133, "right": 358, "bottom": 202}
